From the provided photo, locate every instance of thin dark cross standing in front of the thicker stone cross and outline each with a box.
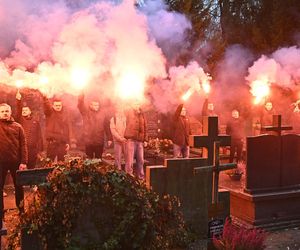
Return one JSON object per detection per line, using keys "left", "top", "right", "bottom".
{"left": 194, "top": 141, "right": 237, "bottom": 204}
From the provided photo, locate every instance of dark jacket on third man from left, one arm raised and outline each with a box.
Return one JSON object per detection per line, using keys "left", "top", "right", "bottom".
{"left": 44, "top": 97, "right": 70, "bottom": 144}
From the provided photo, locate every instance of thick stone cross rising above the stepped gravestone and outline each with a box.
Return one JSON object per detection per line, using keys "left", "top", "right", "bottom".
{"left": 189, "top": 116, "right": 231, "bottom": 165}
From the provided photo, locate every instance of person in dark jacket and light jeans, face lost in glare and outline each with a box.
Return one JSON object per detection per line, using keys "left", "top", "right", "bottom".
{"left": 124, "top": 101, "right": 148, "bottom": 180}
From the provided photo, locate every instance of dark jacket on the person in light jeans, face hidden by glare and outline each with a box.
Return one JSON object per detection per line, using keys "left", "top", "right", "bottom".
{"left": 124, "top": 109, "right": 148, "bottom": 142}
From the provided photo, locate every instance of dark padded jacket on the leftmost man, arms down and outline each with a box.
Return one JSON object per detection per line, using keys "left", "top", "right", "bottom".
{"left": 0, "top": 118, "right": 28, "bottom": 164}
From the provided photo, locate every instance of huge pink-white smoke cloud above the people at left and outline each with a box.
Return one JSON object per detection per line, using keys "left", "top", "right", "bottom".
{"left": 0, "top": 0, "right": 190, "bottom": 104}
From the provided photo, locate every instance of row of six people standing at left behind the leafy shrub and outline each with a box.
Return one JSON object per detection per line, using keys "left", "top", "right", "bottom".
{"left": 0, "top": 91, "right": 147, "bottom": 221}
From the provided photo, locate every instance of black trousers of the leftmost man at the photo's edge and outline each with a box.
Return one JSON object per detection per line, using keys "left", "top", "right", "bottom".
{"left": 0, "top": 162, "right": 24, "bottom": 219}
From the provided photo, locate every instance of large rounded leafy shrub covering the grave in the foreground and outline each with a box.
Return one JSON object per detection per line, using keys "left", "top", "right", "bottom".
{"left": 9, "top": 160, "right": 187, "bottom": 249}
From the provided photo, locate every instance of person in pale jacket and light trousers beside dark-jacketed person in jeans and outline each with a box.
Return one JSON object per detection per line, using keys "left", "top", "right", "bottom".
{"left": 110, "top": 104, "right": 127, "bottom": 170}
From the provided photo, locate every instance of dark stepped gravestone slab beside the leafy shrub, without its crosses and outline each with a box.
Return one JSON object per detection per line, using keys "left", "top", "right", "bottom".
{"left": 146, "top": 158, "right": 212, "bottom": 238}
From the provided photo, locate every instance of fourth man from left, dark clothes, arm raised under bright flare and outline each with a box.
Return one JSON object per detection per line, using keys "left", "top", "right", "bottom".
{"left": 77, "top": 92, "right": 112, "bottom": 159}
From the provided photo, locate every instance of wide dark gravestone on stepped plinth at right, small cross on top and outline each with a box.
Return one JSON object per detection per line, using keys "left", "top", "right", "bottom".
{"left": 230, "top": 116, "right": 300, "bottom": 229}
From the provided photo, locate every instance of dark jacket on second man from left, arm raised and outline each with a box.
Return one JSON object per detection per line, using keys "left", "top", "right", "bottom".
{"left": 16, "top": 100, "right": 43, "bottom": 152}
